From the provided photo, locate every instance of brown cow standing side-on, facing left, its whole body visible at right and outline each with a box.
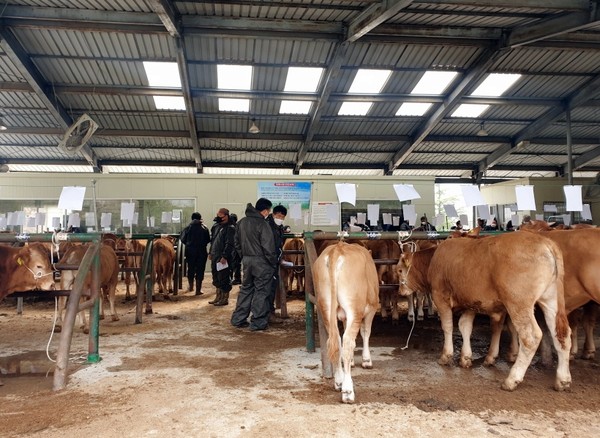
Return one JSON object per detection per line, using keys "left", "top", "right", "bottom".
{"left": 398, "top": 233, "right": 571, "bottom": 391}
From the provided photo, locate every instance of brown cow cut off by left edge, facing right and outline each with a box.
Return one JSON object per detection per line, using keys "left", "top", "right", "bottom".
{"left": 0, "top": 242, "right": 55, "bottom": 300}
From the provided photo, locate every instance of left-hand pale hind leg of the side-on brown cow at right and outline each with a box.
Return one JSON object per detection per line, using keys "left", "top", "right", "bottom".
{"left": 502, "top": 306, "right": 548, "bottom": 391}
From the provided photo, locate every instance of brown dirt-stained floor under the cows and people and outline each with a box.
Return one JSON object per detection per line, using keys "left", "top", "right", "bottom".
{"left": 0, "top": 284, "right": 600, "bottom": 438}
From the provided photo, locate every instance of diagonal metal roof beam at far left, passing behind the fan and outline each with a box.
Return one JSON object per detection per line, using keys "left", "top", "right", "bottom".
{"left": 0, "top": 27, "right": 102, "bottom": 172}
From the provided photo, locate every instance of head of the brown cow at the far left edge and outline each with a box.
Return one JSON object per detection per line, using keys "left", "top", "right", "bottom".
{"left": 13, "top": 242, "right": 55, "bottom": 290}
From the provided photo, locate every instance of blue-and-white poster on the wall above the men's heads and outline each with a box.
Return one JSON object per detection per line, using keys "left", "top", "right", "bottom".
{"left": 258, "top": 181, "right": 312, "bottom": 231}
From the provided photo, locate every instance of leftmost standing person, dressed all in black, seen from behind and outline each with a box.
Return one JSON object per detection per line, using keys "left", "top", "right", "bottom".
{"left": 179, "top": 212, "right": 210, "bottom": 295}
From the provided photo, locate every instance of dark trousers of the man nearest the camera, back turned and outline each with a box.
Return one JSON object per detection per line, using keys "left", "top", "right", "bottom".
{"left": 231, "top": 257, "right": 274, "bottom": 330}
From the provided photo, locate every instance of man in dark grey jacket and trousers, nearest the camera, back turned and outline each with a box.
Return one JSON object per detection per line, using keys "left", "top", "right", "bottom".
{"left": 231, "top": 198, "right": 277, "bottom": 331}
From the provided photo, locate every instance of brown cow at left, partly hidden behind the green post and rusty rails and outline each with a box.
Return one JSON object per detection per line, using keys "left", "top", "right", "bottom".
{"left": 56, "top": 244, "right": 119, "bottom": 333}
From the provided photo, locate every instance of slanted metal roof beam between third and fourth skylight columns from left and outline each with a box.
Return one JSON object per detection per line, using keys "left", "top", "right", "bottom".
{"left": 294, "top": 42, "right": 349, "bottom": 174}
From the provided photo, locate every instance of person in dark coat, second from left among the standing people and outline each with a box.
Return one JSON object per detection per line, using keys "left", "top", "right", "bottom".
{"left": 208, "top": 208, "right": 235, "bottom": 306}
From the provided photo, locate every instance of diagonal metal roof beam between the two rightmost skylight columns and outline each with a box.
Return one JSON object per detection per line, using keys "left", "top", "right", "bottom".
{"left": 387, "top": 45, "right": 501, "bottom": 174}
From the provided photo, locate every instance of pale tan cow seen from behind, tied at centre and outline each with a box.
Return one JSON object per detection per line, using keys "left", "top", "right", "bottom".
{"left": 312, "top": 242, "right": 379, "bottom": 403}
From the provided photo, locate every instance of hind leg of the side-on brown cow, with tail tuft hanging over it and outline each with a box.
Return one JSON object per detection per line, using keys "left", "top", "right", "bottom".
{"left": 538, "top": 294, "right": 571, "bottom": 391}
